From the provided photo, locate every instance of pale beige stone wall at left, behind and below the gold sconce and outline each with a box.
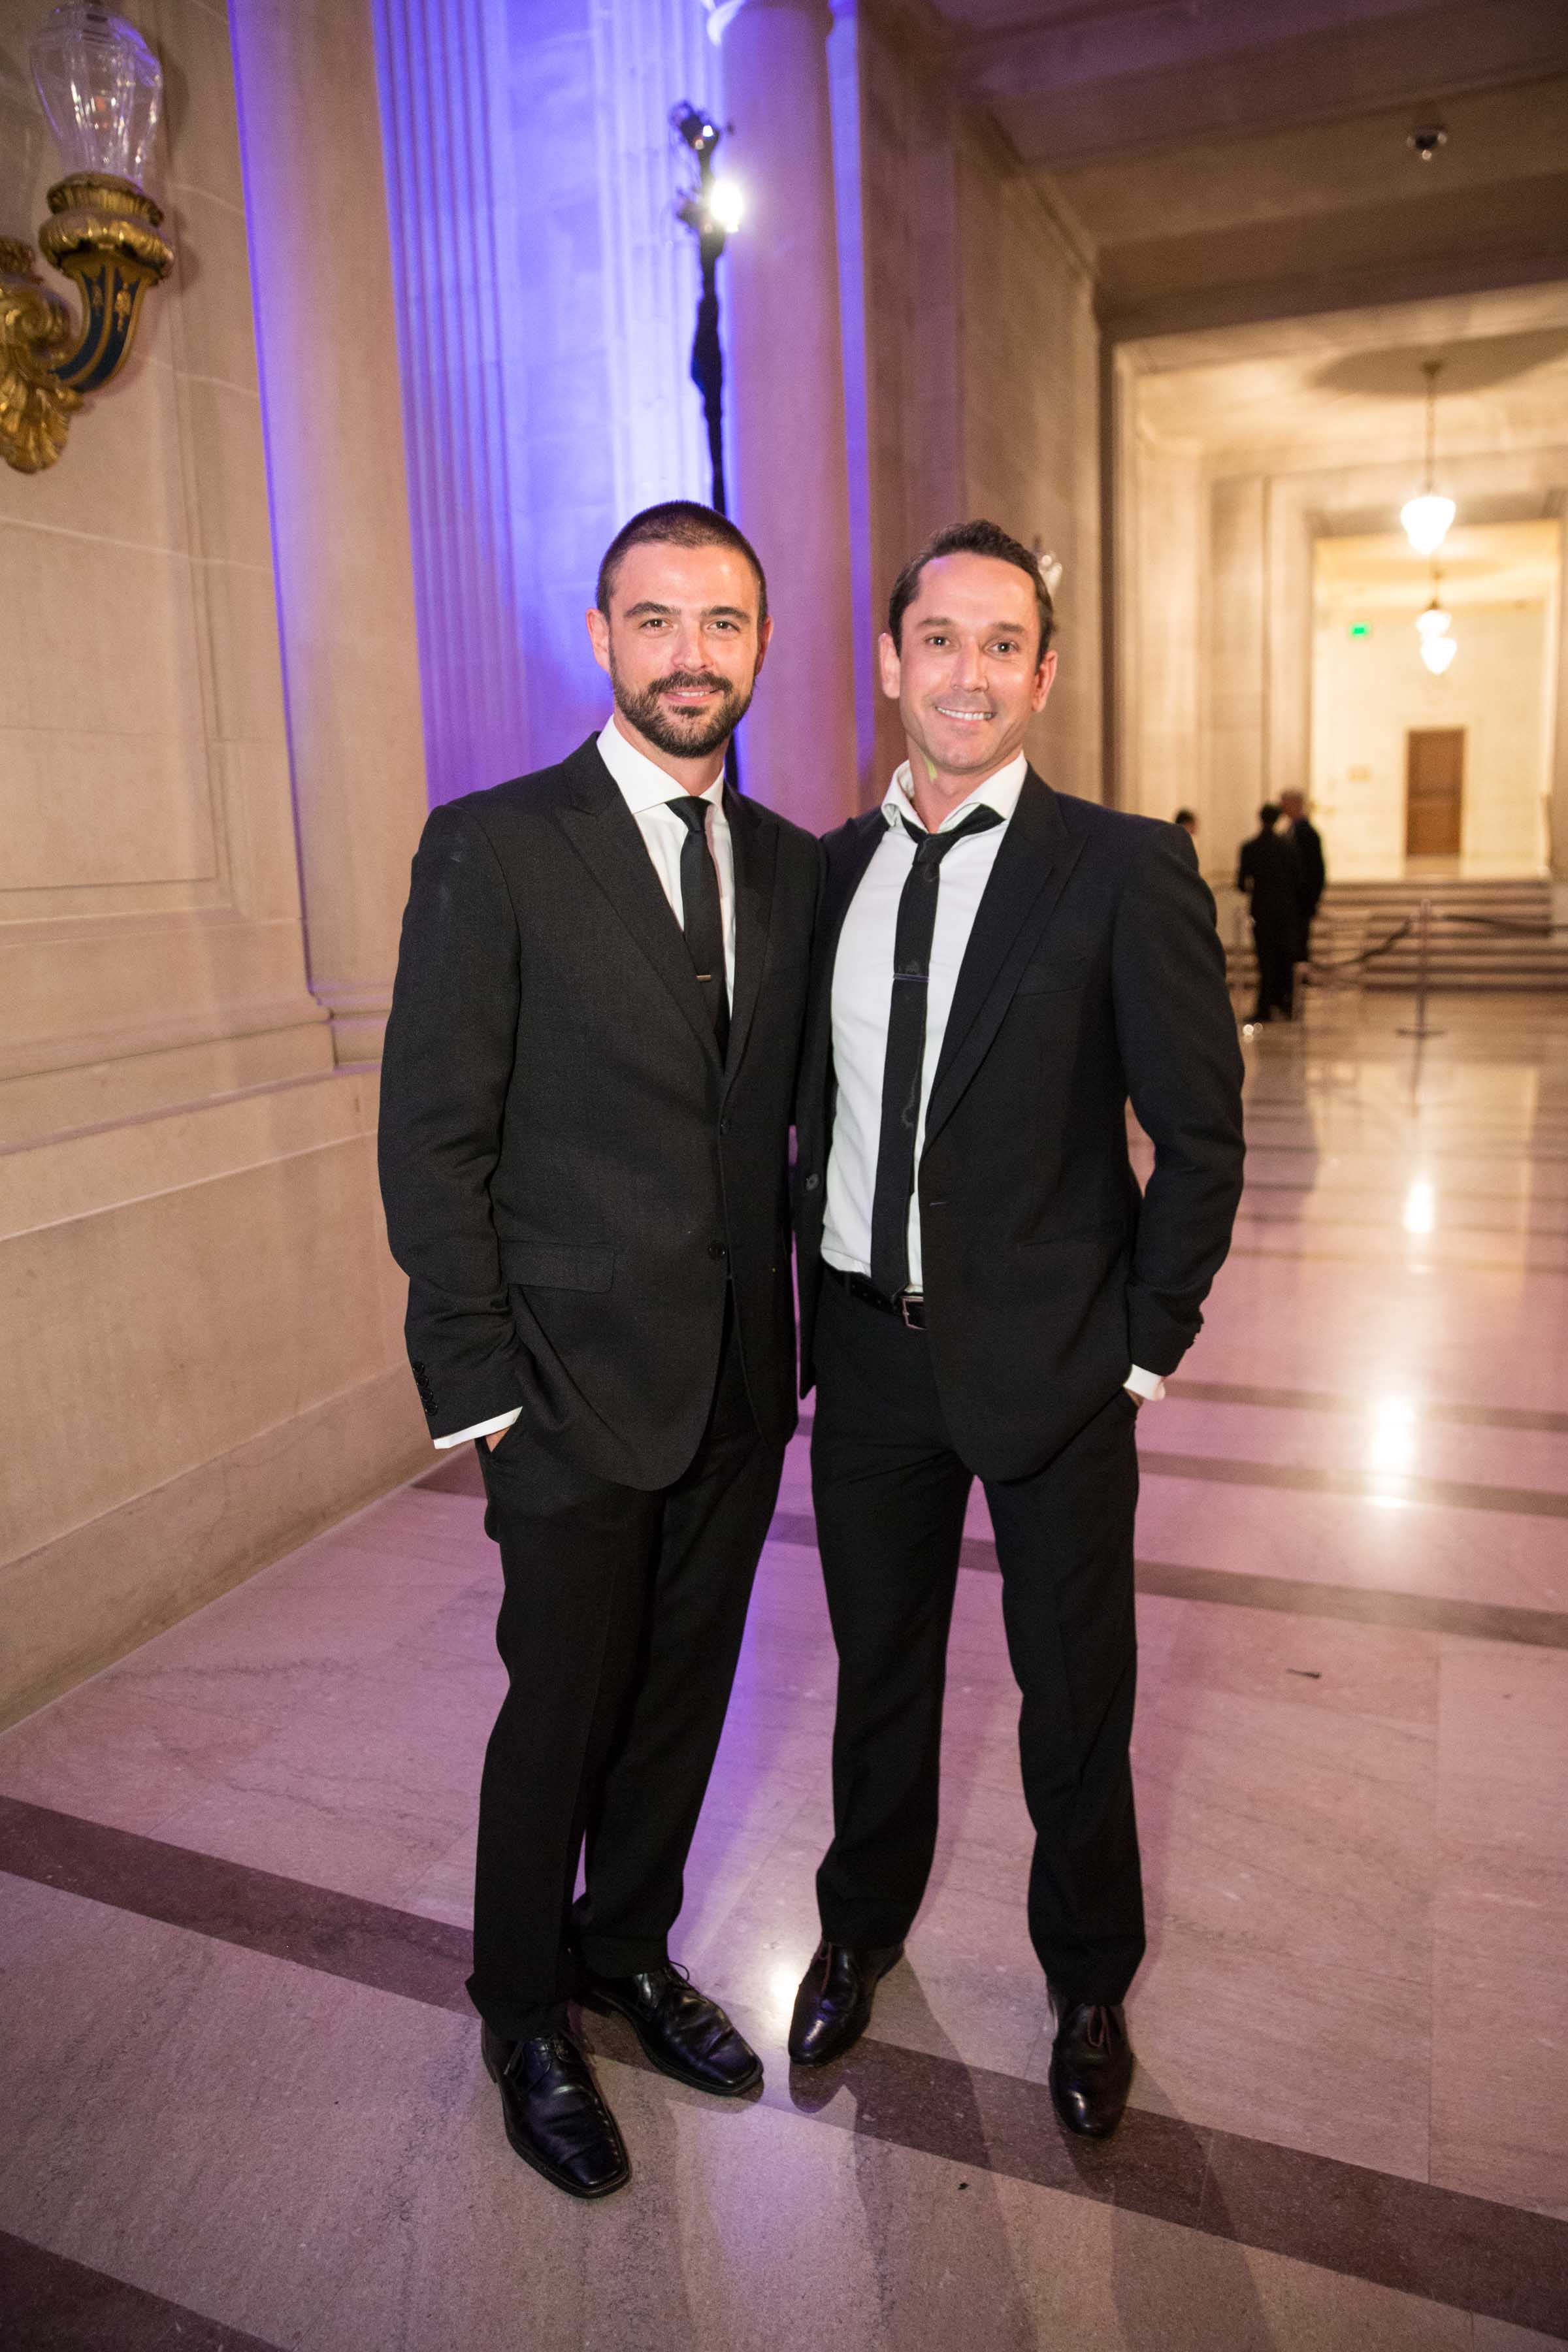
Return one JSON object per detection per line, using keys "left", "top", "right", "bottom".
{"left": 0, "top": 0, "right": 428, "bottom": 1722}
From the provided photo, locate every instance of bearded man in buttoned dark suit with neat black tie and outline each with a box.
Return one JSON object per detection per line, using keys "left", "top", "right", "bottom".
{"left": 381, "top": 503, "right": 823, "bottom": 2197}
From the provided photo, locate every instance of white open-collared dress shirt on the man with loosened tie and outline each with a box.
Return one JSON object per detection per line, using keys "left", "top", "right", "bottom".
{"left": 823, "top": 753, "right": 1164, "bottom": 1397}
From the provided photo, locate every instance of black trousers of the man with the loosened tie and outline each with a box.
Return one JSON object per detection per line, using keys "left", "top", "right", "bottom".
{"left": 811, "top": 1277, "right": 1145, "bottom": 2002}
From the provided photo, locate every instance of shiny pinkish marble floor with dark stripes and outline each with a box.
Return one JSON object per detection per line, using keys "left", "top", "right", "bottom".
{"left": 0, "top": 997, "right": 1568, "bottom": 2352}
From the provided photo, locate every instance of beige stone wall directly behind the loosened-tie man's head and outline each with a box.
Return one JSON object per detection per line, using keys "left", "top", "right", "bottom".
{"left": 840, "top": 5, "right": 1100, "bottom": 800}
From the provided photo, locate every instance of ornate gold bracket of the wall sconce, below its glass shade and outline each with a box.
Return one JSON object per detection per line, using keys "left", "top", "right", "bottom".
{"left": 0, "top": 172, "right": 174, "bottom": 473}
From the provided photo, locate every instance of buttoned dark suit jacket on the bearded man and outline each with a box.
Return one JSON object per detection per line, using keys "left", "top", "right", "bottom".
{"left": 381, "top": 738, "right": 823, "bottom": 1489}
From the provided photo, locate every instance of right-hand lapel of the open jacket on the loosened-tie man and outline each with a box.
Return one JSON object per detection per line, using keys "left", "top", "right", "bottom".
{"left": 926, "top": 769, "right": 1081, "bottom": 1143}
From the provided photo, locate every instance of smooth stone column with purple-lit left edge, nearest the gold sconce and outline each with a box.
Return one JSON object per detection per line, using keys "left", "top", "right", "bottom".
{"left": 228, "top": 0, "right": 425, "bottom": 1063}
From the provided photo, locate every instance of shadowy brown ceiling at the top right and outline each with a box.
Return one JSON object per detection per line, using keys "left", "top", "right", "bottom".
{"left": 907, "top": 0, "right": 1568, "bottom": 338}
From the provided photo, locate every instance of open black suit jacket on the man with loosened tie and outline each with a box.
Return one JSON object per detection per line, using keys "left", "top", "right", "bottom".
{"left": 794, "top": 772, "right": 1243, "bottom": 1479}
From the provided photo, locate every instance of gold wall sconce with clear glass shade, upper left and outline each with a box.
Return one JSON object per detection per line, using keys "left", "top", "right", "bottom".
{"left": 0, "top": 0, "right": 174, "bottom": 473}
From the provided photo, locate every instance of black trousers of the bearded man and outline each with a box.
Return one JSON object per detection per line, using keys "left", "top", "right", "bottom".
{"left": 468, "top": 1315, "right": 783, "bottom": 2042}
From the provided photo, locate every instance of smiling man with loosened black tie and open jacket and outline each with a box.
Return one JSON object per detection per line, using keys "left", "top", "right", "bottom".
{"left": 790, "top": 522, "right": 1241, "bottom": 2133}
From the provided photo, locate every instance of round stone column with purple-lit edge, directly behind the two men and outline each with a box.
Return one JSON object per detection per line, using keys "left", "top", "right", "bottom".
{"left": 724, "top": 0, "right": 856, "bottom": 832}
